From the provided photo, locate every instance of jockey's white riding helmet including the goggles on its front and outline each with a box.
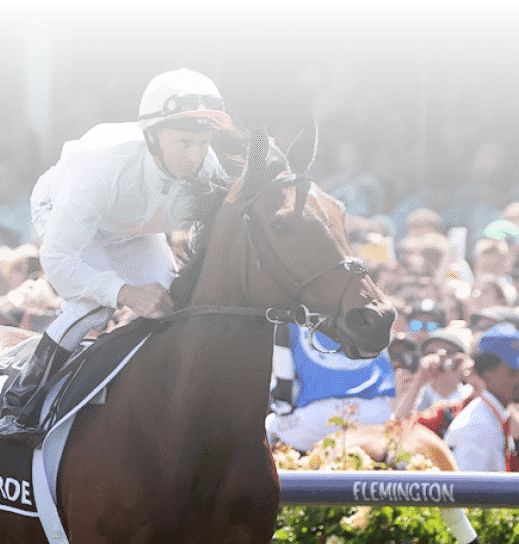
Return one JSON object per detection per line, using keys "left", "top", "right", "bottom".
{"left": 139, "top": 68, "right": 232, "bottom": 130}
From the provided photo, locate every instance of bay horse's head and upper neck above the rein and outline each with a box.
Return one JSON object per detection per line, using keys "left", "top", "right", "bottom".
{"left": 193, "top": 114, "right": 395, "bottom": 359}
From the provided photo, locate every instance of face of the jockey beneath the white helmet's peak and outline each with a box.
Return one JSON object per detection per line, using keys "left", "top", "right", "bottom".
{"left": 153, "top": 128, "right": 213, "bottom": 179}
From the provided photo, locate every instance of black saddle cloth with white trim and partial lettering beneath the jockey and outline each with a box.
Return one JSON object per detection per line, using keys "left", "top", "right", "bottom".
{"left": 0, "top": 318, "right": 171, "bottom": 544}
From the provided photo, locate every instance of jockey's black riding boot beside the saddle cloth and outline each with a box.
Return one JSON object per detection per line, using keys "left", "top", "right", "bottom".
{"left": 0, "top": 333, "right": 71, "bottom": 445}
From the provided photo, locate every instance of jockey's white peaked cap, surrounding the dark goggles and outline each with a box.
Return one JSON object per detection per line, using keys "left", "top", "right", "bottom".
{"left": 139, "top": 68, "right": 232, "bottom": 130}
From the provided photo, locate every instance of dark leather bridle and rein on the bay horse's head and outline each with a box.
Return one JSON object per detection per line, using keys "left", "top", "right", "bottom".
{"left": 159, "top": 173, "right": 367, "bottom": 353}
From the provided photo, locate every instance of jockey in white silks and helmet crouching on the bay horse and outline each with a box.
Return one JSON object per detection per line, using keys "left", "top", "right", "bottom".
{"left": 0, "top": 68, "right": 246, "bottom": 442}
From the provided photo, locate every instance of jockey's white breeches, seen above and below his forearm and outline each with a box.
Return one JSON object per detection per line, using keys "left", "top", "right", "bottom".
{"left": 46, "top": 233, "right": 174, "bottom": 351}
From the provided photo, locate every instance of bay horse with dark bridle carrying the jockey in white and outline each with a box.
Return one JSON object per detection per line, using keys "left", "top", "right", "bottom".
{"left": 0, "top": 112, "right": 395, "bottom": 544}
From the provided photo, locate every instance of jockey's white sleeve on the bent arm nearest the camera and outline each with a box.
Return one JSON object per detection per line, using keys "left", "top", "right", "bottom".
{"left": 40, "top": 153, "right": 126, "bottom": 308}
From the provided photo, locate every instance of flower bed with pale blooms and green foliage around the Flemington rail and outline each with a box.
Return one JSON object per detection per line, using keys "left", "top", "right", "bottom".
{"left": 273, "top": 420, "right": 519, "bottom": 544}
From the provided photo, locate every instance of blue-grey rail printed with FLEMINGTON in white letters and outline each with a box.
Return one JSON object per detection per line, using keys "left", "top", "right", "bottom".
{"left": 278, "top": 470, "right": 519, "bottom": 508}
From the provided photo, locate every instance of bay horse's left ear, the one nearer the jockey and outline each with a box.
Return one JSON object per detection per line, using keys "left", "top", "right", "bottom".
{"left": 241, "top": 117, "right": 269, "bottom": 200}
